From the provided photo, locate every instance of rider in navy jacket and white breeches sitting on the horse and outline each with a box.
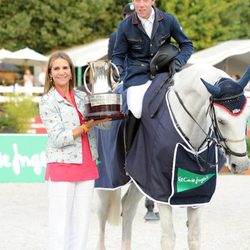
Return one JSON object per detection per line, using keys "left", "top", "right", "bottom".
{"left": 112, "top": 0, "right": 194, "bottom": 152}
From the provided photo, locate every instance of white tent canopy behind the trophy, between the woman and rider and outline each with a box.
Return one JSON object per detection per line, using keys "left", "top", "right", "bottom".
{"left": 64, "top": 38, "right": 109, "bottom": 67}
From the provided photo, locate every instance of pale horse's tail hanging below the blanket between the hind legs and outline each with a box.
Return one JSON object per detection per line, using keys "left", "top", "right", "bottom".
{"left": 107, "top": 188, "right": 121, "bottom": 225}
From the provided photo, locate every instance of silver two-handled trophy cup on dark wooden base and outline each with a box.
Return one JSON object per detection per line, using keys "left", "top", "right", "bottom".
{"left": 83, "top": 60, "right": 125, "bottom": 120}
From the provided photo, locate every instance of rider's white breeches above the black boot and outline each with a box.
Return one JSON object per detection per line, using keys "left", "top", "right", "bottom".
{"left": 127, "top": 80, "right": 152, "bottom": 119}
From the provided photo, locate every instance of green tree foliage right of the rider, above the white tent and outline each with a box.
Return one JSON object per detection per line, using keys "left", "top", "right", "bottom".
{"left": 156, "top": 0, "right": 250, "bottom": 51}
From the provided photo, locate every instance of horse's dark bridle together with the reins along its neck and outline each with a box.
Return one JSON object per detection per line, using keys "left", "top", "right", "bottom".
{"left": 174, "top": 91, "right": 247, "bottom": 157}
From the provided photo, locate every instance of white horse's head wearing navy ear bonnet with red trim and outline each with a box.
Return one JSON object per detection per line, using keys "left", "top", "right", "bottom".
{"left": 201, "top": 67, "right": 250, "bottom": 173}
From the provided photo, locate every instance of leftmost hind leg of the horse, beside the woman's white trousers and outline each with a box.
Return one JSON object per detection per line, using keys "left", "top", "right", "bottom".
{"left": 96, "top": 190, "right": 110, "bottom": 250}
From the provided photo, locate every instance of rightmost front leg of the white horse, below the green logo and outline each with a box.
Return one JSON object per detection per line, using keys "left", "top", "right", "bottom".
{"left": 187, "top": 207, "right": 201, "bottom": 250}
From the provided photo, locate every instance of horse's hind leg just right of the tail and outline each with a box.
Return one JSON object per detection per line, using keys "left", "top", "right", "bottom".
{"left": 122, "top": 183, "right": 143, "bottom": 250}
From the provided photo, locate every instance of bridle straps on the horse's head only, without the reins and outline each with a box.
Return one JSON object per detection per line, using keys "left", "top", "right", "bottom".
{"left": 209, "top": 93, "right": 247, "bottom": 157}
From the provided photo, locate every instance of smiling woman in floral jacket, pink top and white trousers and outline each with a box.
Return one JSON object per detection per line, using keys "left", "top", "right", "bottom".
{"left": 39, "top": 52, "right": 110, "bottom": 250}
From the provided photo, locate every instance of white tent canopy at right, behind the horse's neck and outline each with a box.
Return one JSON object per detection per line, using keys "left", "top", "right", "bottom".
{"left": 188, "top": 40, "right": 250, "bottom": 75}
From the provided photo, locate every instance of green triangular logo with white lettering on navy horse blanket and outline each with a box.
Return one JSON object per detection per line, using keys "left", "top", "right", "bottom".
{"left": 177, "top": 168, "right": 215, "bottom": 192}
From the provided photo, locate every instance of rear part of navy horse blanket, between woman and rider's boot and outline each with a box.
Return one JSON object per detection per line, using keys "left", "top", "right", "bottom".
{"left": 95, "top": 85, "right": 130, "bottom": 190}
